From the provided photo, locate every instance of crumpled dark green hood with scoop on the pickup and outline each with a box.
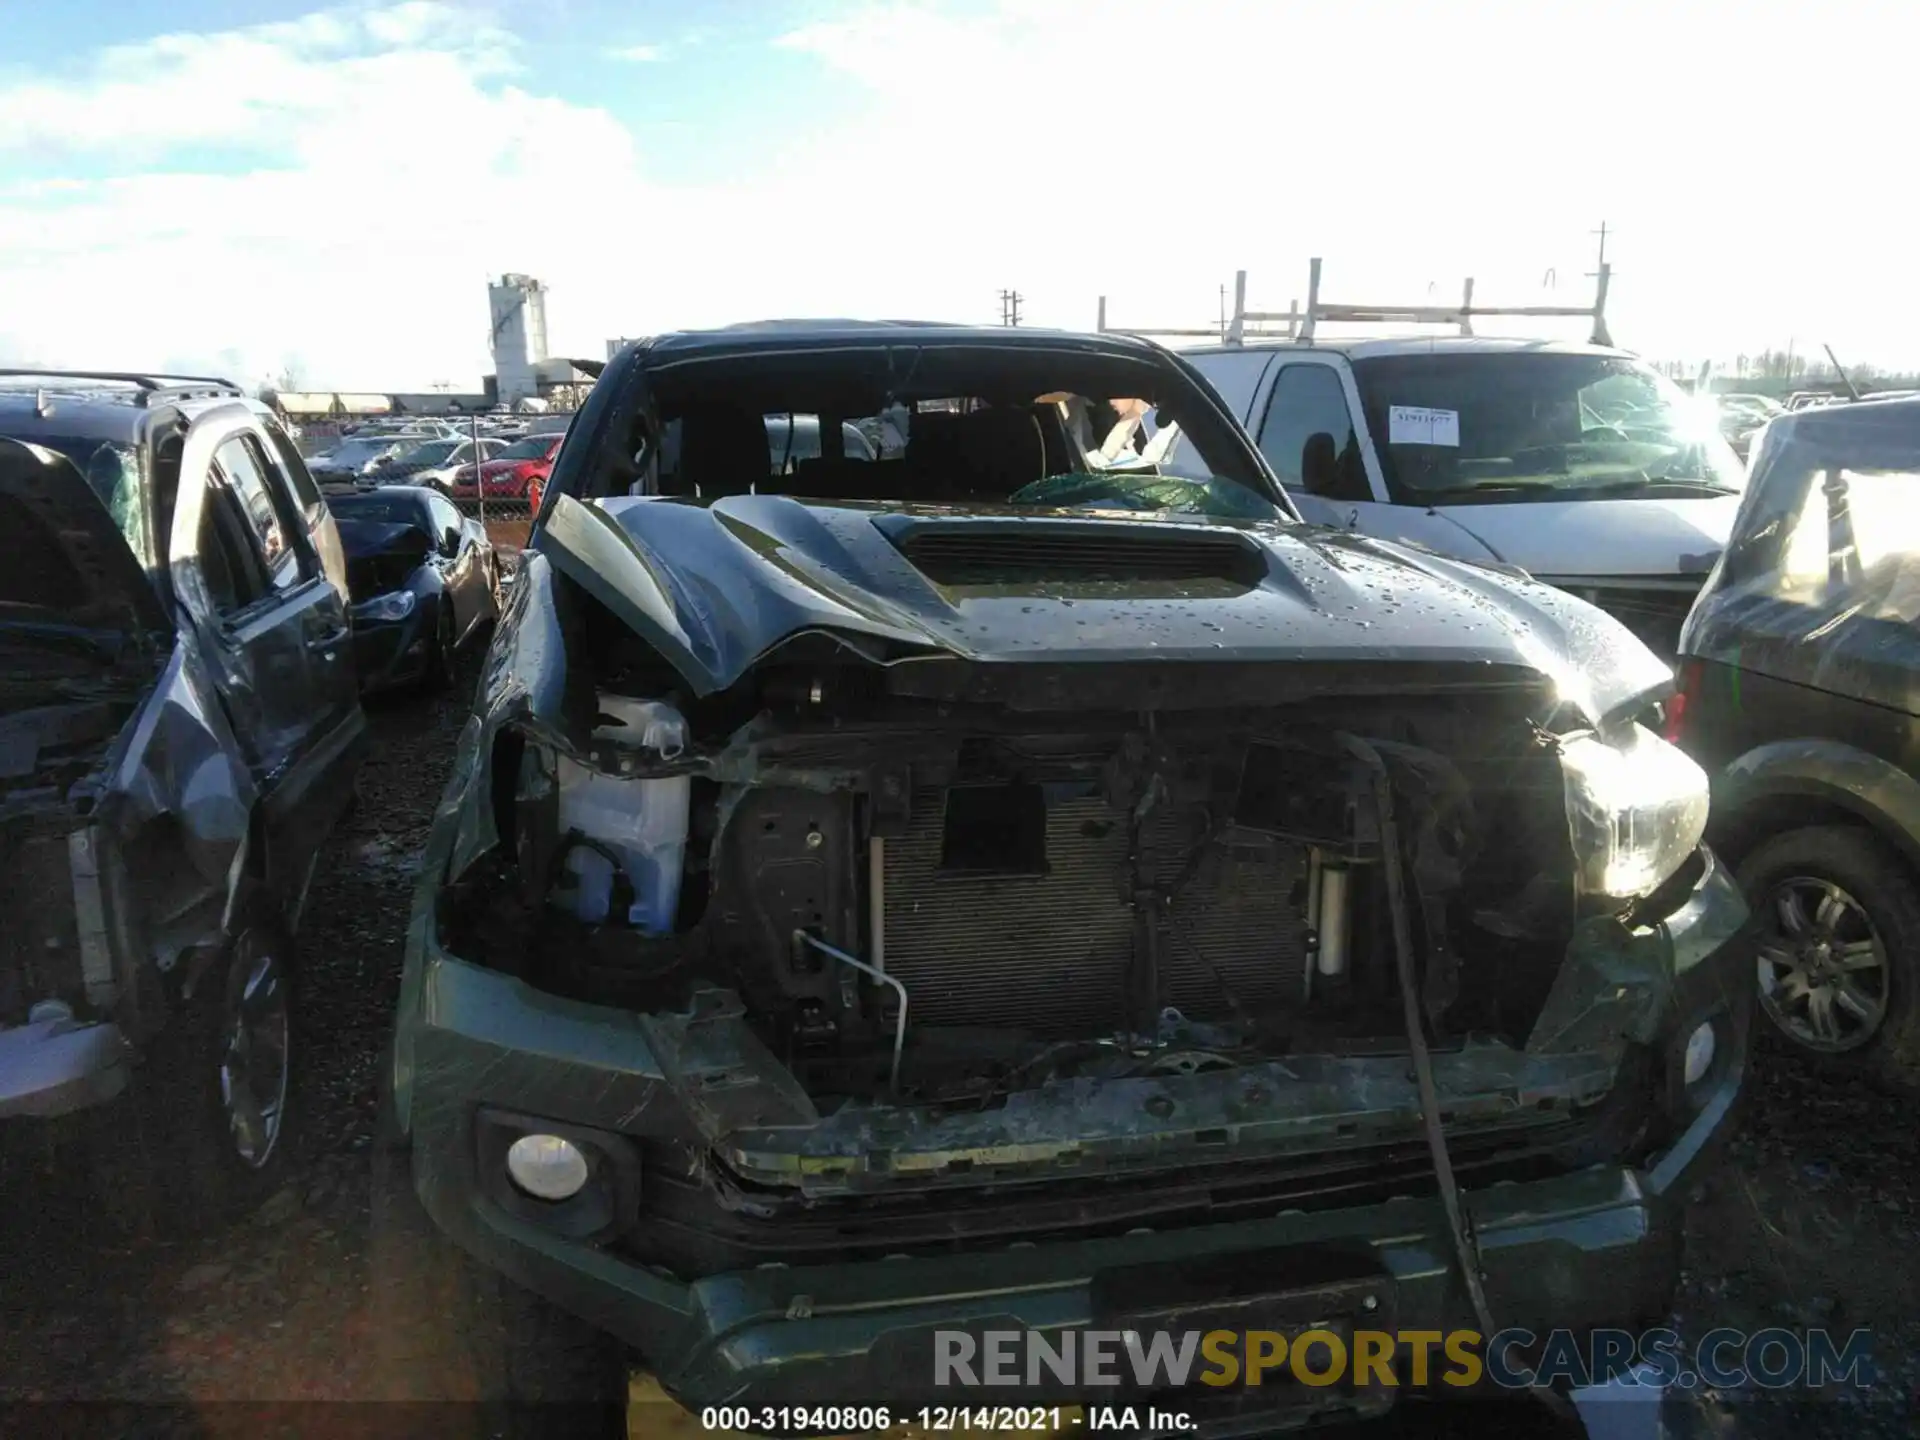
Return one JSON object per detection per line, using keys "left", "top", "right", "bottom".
{"left": 534, "top": 495, "right": 1670, "bottom": 718}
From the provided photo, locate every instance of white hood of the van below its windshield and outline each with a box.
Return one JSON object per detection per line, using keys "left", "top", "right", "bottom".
{"left": 1434, "top": 495, "right": 1740, "bottom": 580}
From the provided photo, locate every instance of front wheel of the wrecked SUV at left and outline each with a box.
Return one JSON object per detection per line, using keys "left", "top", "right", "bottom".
{"left": 134, "top": 904, "right": 300, "bottom": 1235}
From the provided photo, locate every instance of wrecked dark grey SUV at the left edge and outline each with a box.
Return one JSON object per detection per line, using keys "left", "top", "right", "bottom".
{"left": 0, "top": 371, "right": 365, "bottom": 1217}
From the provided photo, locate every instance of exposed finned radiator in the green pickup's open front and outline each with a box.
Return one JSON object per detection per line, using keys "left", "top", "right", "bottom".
{"left": 883, "top": 789, "right": 1306, "bottom": 1037}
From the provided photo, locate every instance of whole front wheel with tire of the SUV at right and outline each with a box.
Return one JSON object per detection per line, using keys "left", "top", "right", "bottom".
{"left": 1740, "top": 826, "right": 1920, "bottom": 1089}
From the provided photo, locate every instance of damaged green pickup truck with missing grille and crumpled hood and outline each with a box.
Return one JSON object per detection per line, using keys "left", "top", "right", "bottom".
{"left": 392, "top": 323, "right": 1753, "bottom": 1428}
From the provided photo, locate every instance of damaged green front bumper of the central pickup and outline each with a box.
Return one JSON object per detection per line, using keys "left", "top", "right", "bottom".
{"left": 396, "top": 862, "right": 1753, "bottom": 1407}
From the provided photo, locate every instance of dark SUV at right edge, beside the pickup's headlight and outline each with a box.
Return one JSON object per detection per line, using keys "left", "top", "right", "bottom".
{"left": 1668, "top": 399, "right": 1920, "bottom": 1081}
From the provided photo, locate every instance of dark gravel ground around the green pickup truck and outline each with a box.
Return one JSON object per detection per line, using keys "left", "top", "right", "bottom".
{"left": 0, "top": 662, "right": 1920, "bottom": 1440}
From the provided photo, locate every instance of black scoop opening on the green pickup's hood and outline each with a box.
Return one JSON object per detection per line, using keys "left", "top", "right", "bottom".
{"left": 900, "top": 524, "right": 1267, "bottom": 588}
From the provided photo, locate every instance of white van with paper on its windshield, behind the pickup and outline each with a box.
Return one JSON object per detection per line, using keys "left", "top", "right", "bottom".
{"left": 1167, "top": 336, "right": 1745, "bottom": 657}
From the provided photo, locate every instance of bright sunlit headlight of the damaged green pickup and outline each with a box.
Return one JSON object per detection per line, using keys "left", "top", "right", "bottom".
{"left": 1561, "top": 726, "right": 1707, "bottom": 900}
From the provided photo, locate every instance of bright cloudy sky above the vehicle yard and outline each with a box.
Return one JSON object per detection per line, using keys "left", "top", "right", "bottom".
{"left": 0, "top": 0, "right": 1920, "bottom": 390}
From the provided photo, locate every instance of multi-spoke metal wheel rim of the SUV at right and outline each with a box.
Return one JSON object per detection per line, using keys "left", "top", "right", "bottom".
{"left": 1759, "top": 876, "right": 1893, "bottom": 1054}
